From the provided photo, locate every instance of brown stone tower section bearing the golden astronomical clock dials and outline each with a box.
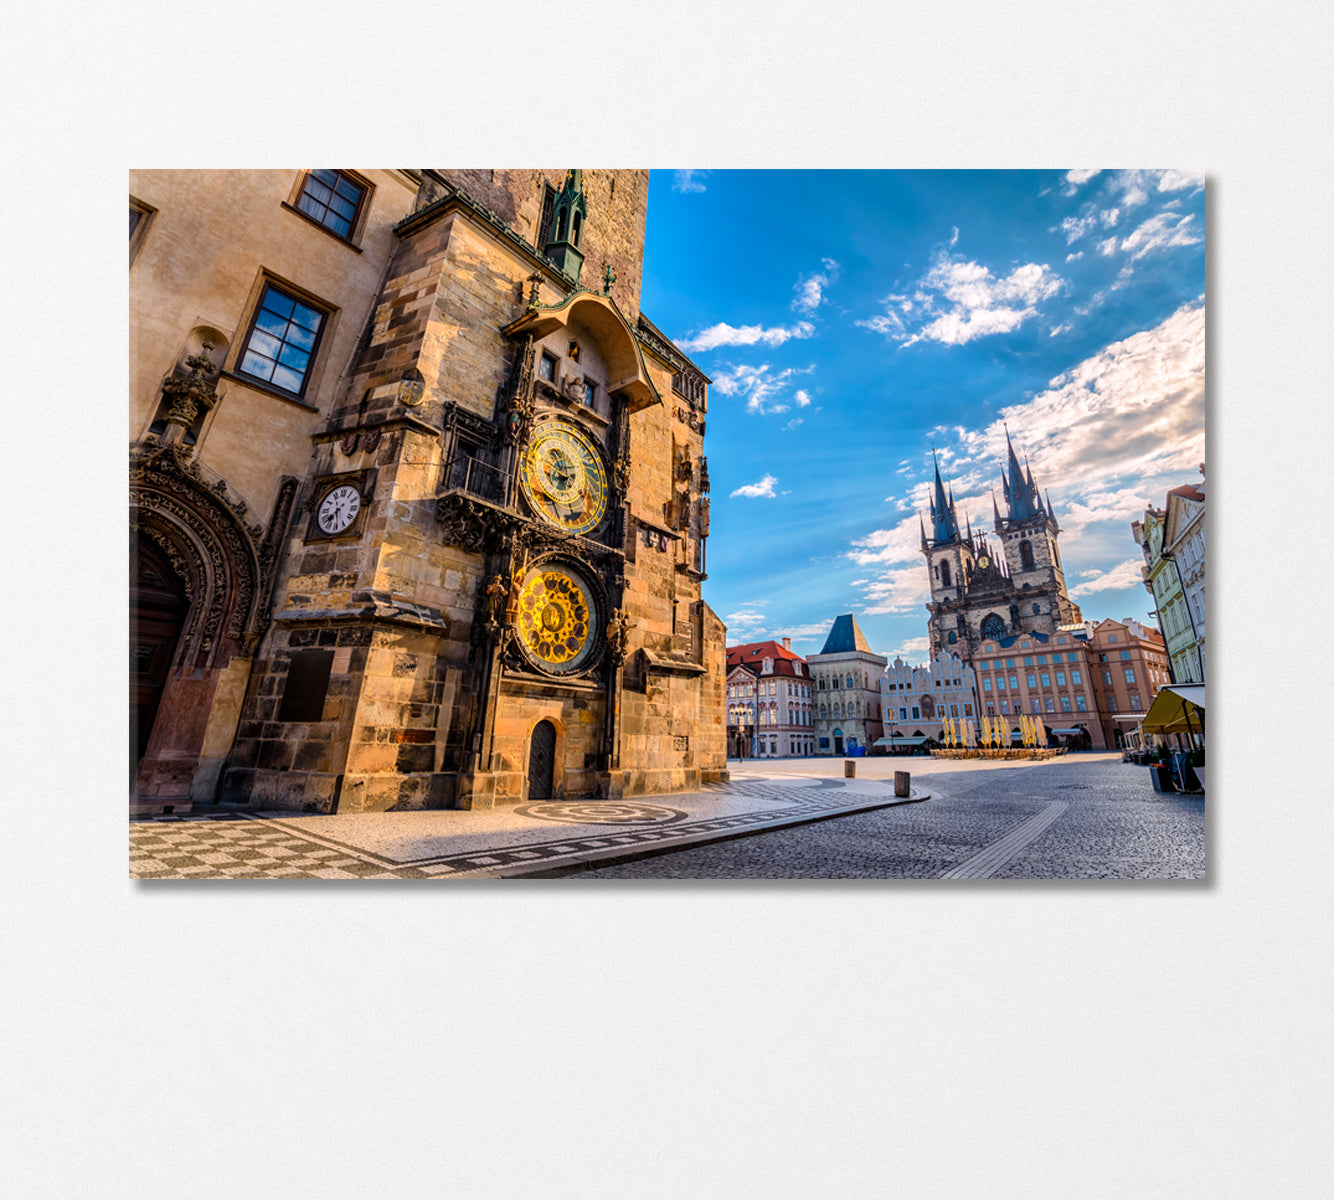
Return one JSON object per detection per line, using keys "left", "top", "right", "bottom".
{"left": 223, "top": 171, "right": 726, "bottom": 812}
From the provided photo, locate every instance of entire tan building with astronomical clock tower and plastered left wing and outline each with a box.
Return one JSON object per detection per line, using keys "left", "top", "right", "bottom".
{"left": 131, "top": 171, "right": 726, "bottom": 812}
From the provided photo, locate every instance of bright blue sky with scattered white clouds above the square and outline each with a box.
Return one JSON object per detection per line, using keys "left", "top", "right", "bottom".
{"left": 643, "top": 169, "right": 1205, "bottom": 663}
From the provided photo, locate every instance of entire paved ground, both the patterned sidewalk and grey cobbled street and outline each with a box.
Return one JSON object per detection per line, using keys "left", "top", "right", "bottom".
{"left": 129, "top": 759, "right": 1205, "bottom": 879}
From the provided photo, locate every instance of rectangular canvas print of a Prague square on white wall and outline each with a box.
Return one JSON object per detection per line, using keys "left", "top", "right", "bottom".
{"left": 128, "top": 168, "right": 1207, "bottom": 881}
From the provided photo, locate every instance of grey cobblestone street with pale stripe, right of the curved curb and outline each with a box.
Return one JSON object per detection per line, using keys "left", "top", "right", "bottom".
{"left": 578, "top": 756, "right": 1205, "bottom": 879}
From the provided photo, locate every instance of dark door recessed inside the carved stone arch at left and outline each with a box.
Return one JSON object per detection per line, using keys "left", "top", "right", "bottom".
{"left": 129, "top": 537, "right": 189, "bottom": 781}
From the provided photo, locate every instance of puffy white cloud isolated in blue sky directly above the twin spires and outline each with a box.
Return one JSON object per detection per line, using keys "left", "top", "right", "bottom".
{"left": 856, "top": 251, "right": 1065, "bottom": 347}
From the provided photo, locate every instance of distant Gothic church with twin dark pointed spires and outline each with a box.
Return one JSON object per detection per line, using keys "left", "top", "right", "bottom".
{"left": 922, "top": 431, "right": 1083, "bottom": 663}
